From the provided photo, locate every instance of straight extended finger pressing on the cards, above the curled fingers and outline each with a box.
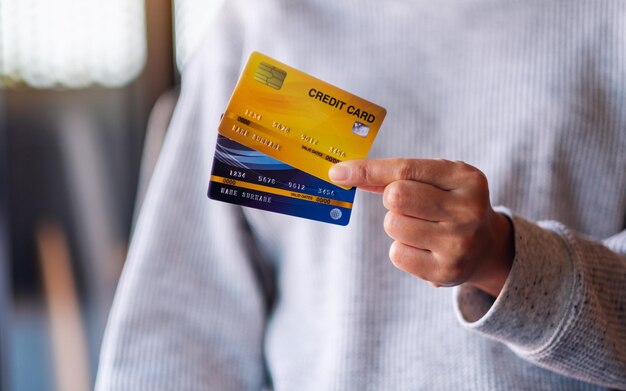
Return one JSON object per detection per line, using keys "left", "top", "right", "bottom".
{"left": 328, "top": 158, "right": 459, "bottom": 190}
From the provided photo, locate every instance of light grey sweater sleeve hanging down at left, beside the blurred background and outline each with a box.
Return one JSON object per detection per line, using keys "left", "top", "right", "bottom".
{"left": 96, "top": 2, "right": 268, "bottom": 390}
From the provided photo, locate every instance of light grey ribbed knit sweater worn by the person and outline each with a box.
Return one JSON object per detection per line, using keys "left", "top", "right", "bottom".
{"left": 97, "top": 0, "right": 626, "bottom": 391}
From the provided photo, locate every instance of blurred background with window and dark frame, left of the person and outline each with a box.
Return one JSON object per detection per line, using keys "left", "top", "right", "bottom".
{"left": 0, "top": 0, "right": 222, "bottom": 391}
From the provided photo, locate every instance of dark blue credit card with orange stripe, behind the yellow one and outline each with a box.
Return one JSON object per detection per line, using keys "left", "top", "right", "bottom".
{"left": 208, "top": 135, "right": 356, "bottom": 225}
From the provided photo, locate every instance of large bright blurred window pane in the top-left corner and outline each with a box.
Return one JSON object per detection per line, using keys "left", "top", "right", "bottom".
{"left": 0, "top": 0, "right": 146, "bottom": 88}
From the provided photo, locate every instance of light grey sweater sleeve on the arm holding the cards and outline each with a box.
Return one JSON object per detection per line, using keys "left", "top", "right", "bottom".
{"left": 455, "top": 209, "right": 626, "bottom": 389}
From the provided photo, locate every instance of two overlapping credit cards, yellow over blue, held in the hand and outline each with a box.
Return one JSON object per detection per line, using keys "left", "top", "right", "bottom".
{"left": 208, "top": 52, "right": 386, "bottom": 225}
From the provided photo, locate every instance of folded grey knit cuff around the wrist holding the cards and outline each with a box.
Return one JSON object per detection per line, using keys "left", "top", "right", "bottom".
{"left": 455, "top": 208, "right": 575, "bottom": 354}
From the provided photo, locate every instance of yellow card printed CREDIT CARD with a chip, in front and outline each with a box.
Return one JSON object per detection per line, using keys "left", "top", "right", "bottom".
{"left": 219, "top": 52, "right": 387, "bottom": 187}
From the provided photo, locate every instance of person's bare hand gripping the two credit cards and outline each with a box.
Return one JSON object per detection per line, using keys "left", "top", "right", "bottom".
{"left": 329, "top": 159, "right": 514, "bottom": 297}
